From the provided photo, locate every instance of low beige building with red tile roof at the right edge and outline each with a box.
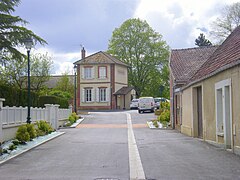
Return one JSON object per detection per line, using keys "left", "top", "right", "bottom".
{"left": 170, "top": 27, "right": 240, "bottom": 154}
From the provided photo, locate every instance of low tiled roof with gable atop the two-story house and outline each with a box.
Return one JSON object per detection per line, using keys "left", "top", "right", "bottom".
{"left": 74, "top": 51, "right": 129, "bottom": 67}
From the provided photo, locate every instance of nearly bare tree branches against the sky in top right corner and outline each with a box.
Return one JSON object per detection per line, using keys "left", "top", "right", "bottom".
{"left": 210, "top": 2, "right": 240, "bottom": 42}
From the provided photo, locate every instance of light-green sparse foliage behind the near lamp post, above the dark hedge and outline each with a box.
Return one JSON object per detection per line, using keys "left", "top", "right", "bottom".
{"left": 0, "top": 53, "right": 53, "bottom": 91}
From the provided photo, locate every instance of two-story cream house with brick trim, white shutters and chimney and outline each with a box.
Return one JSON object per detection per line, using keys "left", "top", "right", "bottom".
{"left": 74, "top": 48, "right": 135, "bottom": 110}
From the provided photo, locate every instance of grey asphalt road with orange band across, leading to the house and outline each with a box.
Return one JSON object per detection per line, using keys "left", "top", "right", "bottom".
{"left": 0, "top": 111, "right": 240, "bottom": 180}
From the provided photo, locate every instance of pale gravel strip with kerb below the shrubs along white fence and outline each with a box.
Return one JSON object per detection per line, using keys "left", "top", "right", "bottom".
{"left": 0, "top": 131, "right": 65, "bottom": 165}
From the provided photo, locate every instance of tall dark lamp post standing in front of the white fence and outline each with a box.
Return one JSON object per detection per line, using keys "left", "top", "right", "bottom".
{"left": 24, "top": 38, "right": 33, "bottom": 124}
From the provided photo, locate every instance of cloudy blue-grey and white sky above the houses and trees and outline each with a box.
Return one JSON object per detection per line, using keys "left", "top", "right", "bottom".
{"left": 14, "top": 0, "right": 238, "bottom": 74}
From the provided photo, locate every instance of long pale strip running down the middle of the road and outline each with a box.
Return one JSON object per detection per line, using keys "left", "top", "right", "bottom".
{"left": 126, "top": 113, "right": 145, "bottom": 180}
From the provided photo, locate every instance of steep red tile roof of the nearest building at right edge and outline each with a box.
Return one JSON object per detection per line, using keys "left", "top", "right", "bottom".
{"left": 190, "top": 26, "right": 240, "bottom": 83}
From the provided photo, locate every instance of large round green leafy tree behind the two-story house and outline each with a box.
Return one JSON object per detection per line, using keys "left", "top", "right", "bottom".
{"left": 108, "top": 19, "right": 169, "bottom": 96}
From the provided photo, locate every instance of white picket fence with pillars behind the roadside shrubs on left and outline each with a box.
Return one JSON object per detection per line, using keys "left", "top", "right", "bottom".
{"left": 0, "top": 98, "right": 72, "bottom": 142}
